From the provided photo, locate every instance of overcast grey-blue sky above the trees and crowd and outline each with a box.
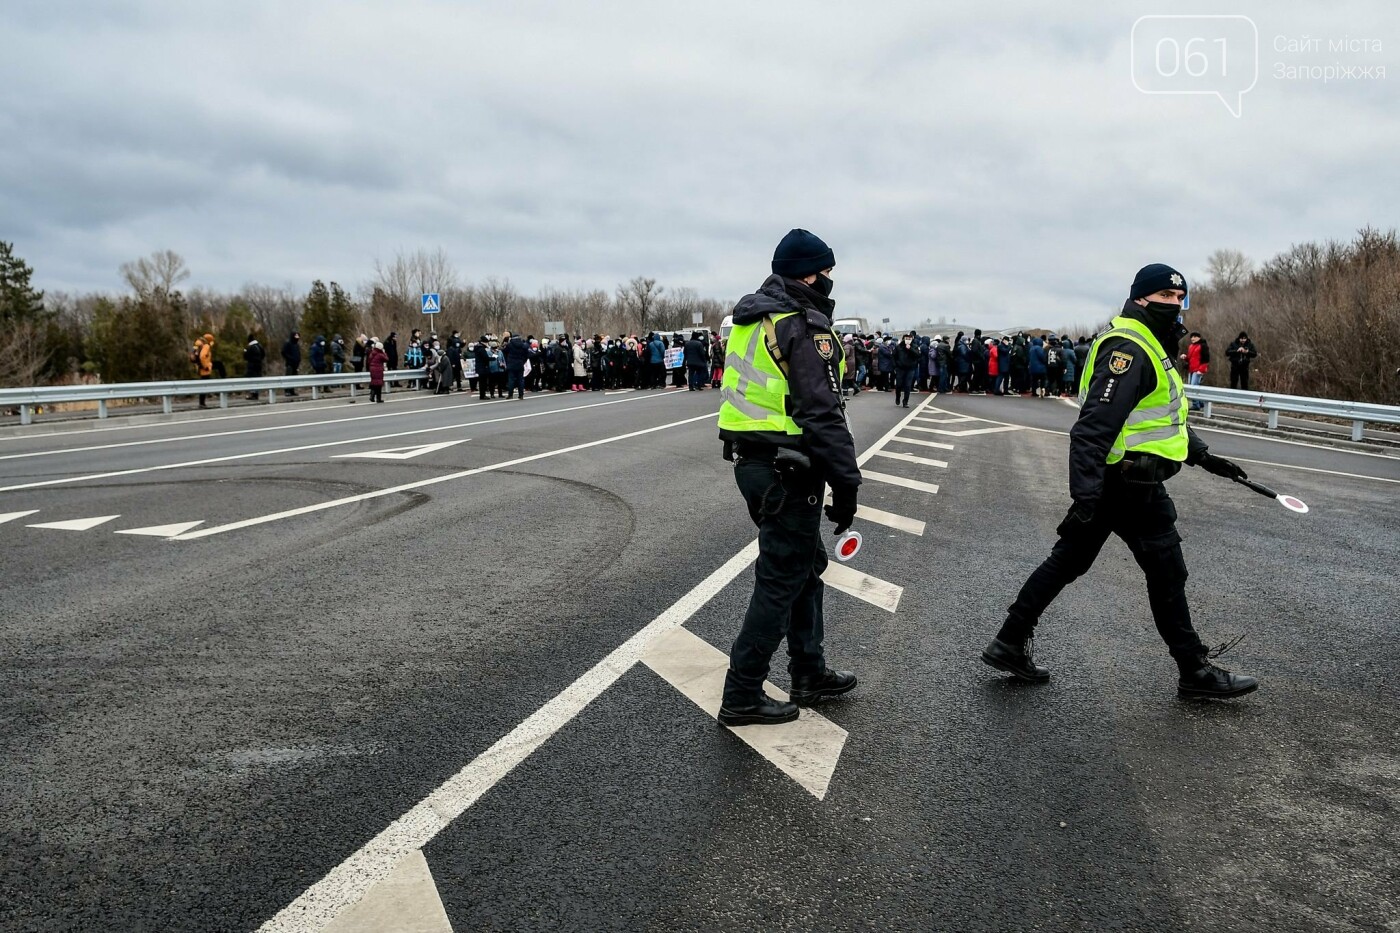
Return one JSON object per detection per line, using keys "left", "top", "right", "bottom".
{"left": 0, "top": 0, "right": 1400, "bottom": 326}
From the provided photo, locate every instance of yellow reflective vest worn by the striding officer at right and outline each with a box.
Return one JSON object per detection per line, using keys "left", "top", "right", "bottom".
{"left": 1079, "top": 317, "right": 1187, "bottom": 464}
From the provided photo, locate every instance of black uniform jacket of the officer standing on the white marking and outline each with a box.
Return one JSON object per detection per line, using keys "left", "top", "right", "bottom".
{"left": 720, "top": 275, "right": 861, "bottom": 486}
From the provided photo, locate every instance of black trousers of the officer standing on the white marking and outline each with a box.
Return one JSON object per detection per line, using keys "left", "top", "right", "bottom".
{"left": 724, "top": 457, "right": 827, "bottom": 706}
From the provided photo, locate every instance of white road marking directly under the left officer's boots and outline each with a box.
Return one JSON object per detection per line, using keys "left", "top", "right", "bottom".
{"left": 641, "top": 628, "right": 846, "bottom": 800}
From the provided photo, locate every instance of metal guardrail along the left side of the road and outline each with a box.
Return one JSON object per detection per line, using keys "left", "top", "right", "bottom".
{"left": 0, "top": 368, "right": 431, "bottom": 424}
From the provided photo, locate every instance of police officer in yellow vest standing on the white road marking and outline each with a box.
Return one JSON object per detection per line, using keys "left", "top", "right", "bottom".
{"left": 720, "top": 230, "right": 861, "bottom": 726}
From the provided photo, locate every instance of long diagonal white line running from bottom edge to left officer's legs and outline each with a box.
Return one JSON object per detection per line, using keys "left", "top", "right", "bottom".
{"left": 259, "top": 537, "right": 759, "bottom": 933}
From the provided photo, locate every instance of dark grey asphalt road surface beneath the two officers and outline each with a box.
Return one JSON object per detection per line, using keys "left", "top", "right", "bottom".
{"left": 0, "top": 381, "right": 1400, "bottom": 933}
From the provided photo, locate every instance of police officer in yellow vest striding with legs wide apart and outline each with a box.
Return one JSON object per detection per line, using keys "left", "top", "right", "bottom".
{"left": 981, "top": 263, "right": 1259, "bottom": 698}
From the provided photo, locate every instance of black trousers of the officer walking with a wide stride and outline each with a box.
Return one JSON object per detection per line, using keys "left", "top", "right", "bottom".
{"left": 1007, "top": 469, "right": 1205, "bottom": 660}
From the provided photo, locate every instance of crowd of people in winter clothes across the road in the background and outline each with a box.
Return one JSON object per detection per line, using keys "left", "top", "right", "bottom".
{"left": 229, "top": 323, "right": 1259, "bottom": 406}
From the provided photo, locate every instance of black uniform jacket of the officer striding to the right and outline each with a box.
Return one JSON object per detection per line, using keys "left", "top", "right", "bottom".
{"left": 1070, "top": 301, "right": 1207, "bottom": 507}
